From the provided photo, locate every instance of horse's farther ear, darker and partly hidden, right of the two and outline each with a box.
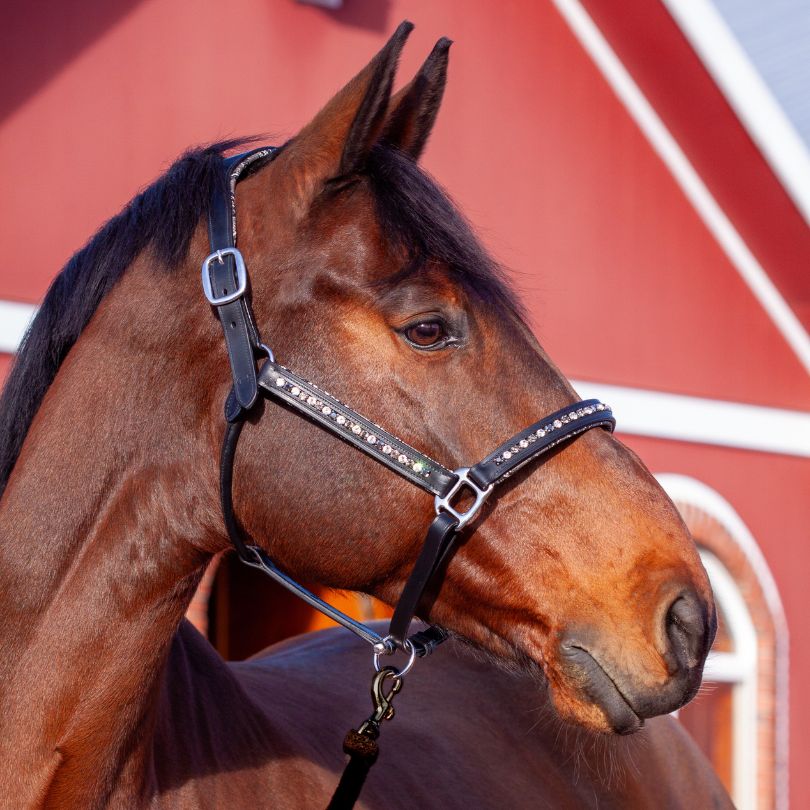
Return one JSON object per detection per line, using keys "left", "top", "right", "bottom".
{"left": 383, "top": 37, "right": 453, "bottom": 160}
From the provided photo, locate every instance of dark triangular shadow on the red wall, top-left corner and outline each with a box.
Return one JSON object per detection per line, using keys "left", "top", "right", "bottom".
{"left": 0, "top": 0, "right": 142, "bottom": 121}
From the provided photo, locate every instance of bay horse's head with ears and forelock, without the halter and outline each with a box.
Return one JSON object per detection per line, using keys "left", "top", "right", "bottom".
{"left": 192, "top": 24, "right": 715, "bottom": 733}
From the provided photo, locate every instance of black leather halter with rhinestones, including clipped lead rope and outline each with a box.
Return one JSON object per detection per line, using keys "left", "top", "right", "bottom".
{"left": 202, "top": 146, "right": 616, "bottom": 808}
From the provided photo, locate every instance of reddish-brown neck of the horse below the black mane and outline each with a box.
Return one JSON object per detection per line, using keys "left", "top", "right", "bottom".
{"left": 0, "top": 252, "right": 221, "bottom": 807}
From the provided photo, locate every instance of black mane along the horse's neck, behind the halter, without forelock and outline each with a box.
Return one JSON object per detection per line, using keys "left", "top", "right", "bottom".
{"left": 0, "top": 141, "right": 251, "bottom": 496}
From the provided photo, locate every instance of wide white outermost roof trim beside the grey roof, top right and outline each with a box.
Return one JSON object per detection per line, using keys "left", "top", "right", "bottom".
{"left": 663, "top": 0, "right": 810, "bottom": 223}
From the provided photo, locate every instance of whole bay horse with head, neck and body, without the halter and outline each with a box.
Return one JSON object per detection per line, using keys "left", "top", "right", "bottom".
{"left": 0, "top": 24, "right": 730, "bottom": 808}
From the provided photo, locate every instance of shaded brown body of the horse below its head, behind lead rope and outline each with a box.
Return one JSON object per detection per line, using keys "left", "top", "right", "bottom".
{"left": 148, "top": 623, "right": 732, "bottom": 810}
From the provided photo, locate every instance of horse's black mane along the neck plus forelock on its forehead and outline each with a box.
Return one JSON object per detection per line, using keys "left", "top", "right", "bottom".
{"left": 0, "top": 139, "right": 521, "bottom": 496}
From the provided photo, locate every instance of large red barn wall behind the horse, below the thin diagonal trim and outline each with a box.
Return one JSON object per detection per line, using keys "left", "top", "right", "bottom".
{"left": 0, "top": 0, "right": 810, "bottom": 807}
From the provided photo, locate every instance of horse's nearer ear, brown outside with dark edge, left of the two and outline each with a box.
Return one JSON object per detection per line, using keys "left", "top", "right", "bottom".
{"left": 279, "top": 20, "right": 413, "bottom": 203}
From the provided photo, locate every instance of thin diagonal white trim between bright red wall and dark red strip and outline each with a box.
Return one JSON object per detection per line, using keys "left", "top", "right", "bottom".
{"left": 554, "top": 0, "right": 810, "bottom": 372}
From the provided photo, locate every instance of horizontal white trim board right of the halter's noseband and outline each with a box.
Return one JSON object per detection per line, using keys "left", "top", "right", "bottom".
{"left": 571, "top": 380, "right": 810, "bottom": 458}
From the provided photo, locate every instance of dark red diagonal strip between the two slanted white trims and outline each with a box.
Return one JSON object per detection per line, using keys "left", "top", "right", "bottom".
{"left": 584, "top": 0, "right": 810, "bottom": 328}
